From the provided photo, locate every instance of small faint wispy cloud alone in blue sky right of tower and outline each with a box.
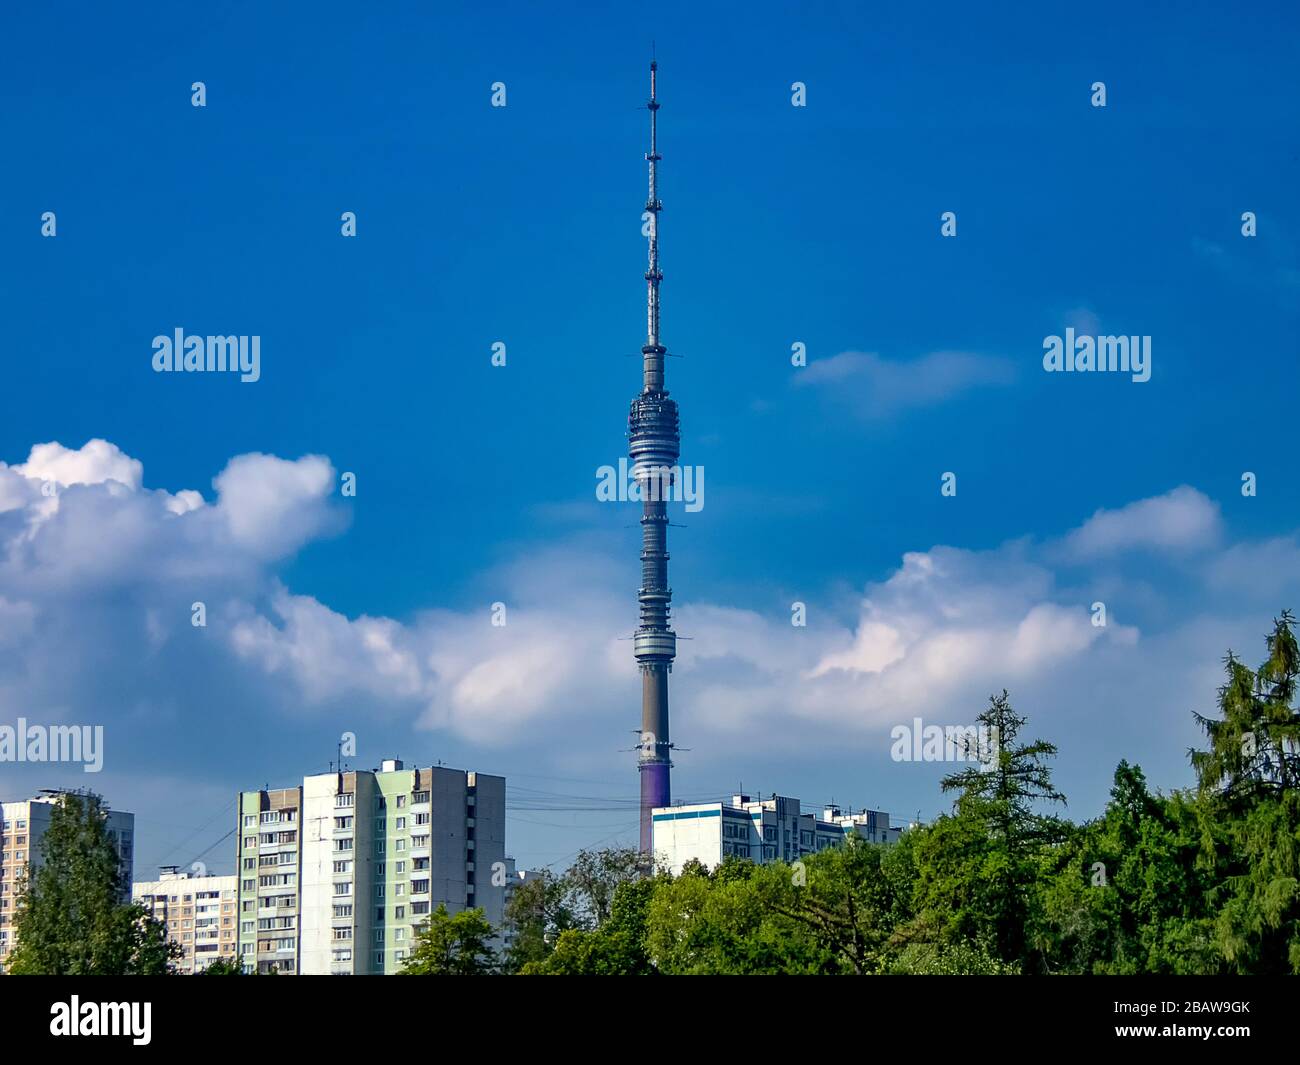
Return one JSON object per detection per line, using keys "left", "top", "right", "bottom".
{"left": 794, "top": 351, "right": 1014, "bottom": 419}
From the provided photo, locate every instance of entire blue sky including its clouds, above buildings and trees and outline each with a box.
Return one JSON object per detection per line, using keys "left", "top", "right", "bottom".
{"left": 0, "top": 3, "right": 1300, "bottom": 874}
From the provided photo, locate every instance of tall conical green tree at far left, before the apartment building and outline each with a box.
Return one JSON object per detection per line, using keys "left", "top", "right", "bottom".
{"left": 9, "top": 793, "right": 181, "bottom": 977}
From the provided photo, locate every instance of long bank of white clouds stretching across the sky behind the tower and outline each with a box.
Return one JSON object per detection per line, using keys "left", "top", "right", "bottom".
{"left": 0, "top": 441, "right": 1297, "bottom": 795}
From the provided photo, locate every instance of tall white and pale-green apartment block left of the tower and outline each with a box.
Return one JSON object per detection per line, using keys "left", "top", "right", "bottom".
{"left": 238, "top": 759, "right": 507, "bottom": 975}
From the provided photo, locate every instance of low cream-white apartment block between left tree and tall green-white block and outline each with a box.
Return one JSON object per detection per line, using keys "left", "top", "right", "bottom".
{"left": 131, "top": 866, "right": 238, "bottom": 974}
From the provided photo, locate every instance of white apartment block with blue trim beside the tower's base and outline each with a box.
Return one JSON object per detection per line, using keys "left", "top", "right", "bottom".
{"left": 651, "top": 795, "right": 902, "bottom": 876}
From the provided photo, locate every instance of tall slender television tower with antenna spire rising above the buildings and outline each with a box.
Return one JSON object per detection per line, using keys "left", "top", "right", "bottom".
{"left": 628, "top": 60, "right": 681, "bottom": 854}
